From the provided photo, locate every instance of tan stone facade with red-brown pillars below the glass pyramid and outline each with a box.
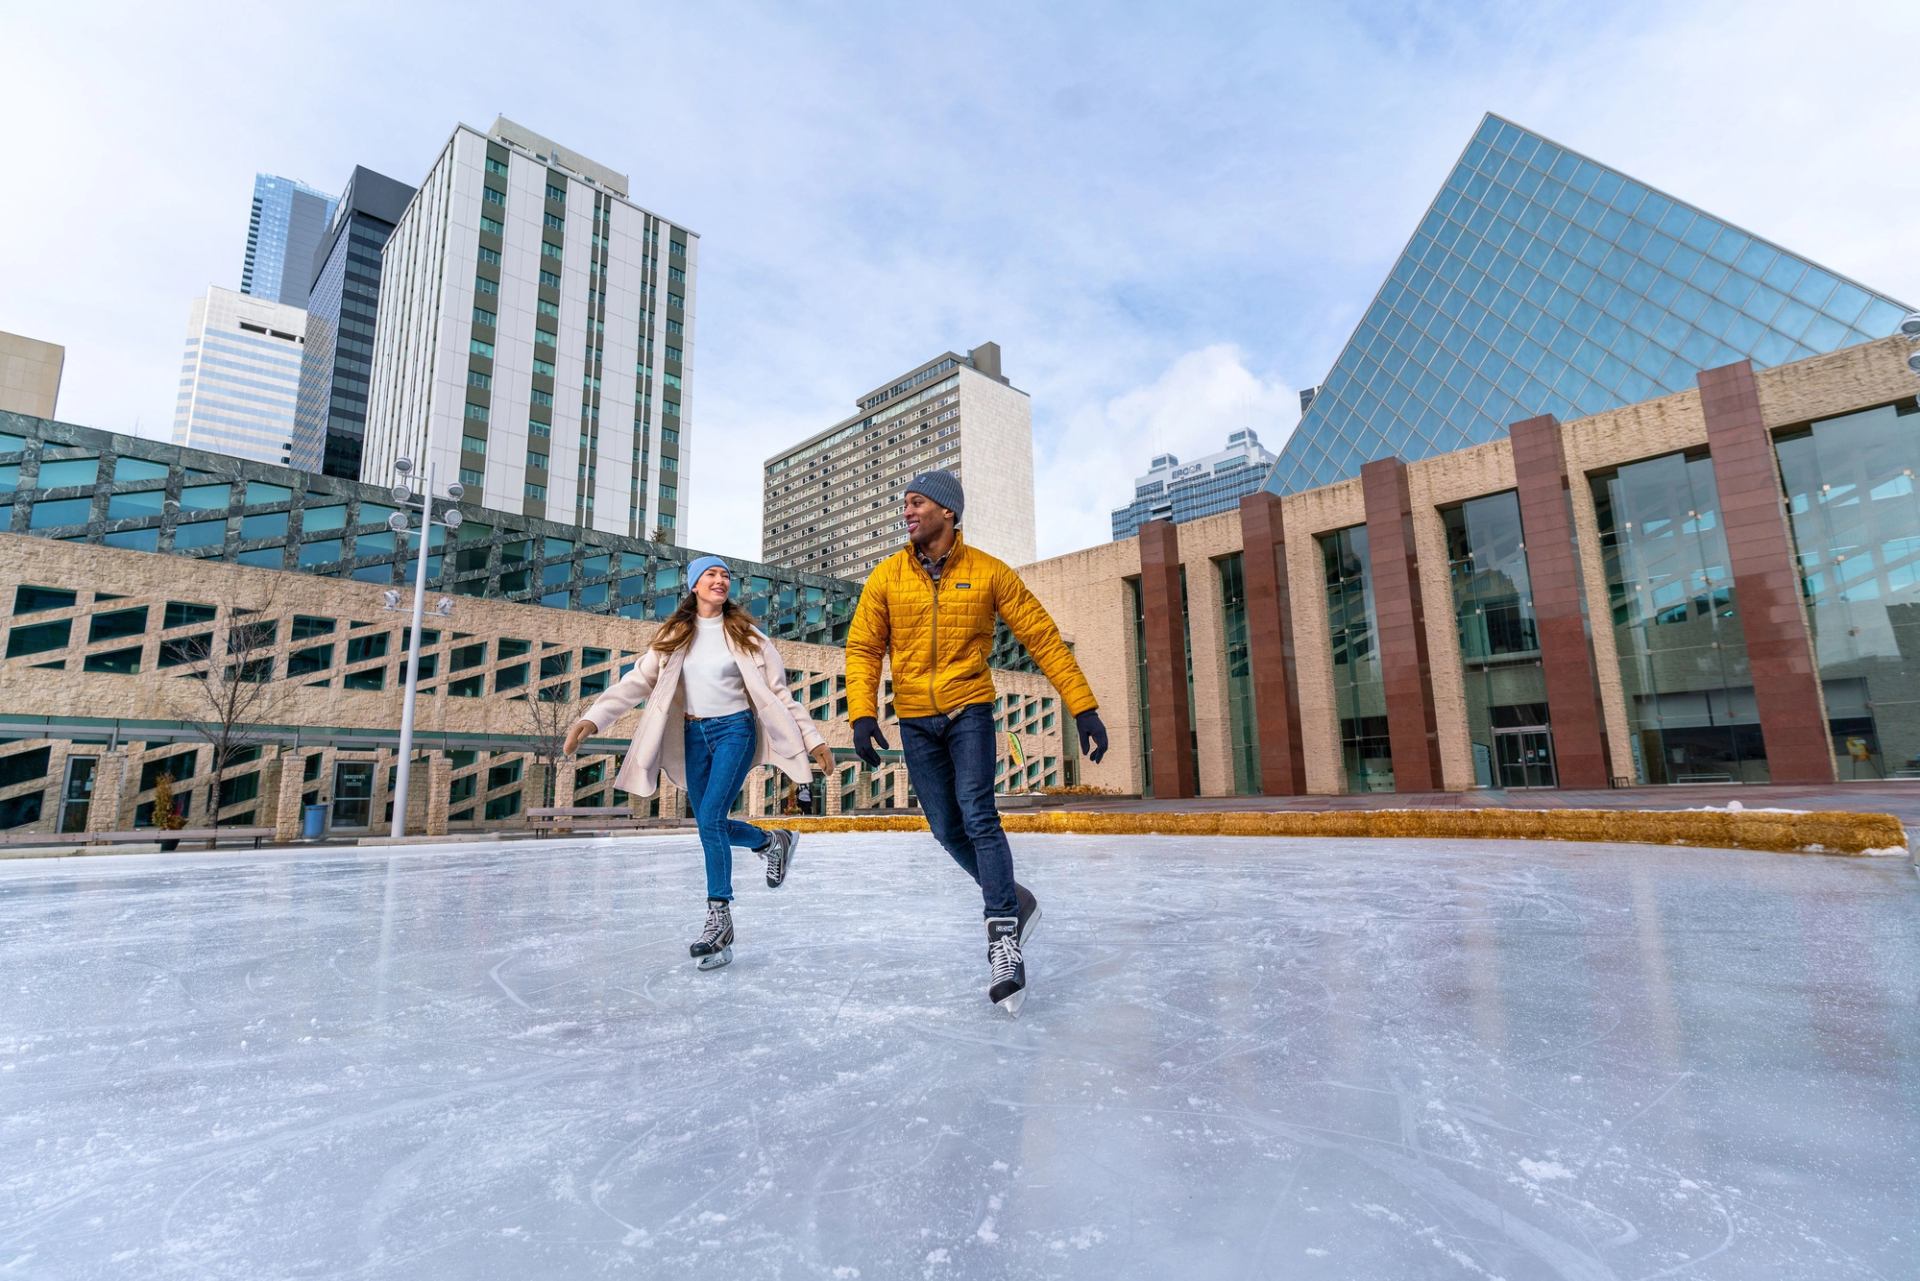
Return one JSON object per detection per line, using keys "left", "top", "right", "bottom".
{"left": 1021, "top": 338, "right": 1920, "bottom": 795}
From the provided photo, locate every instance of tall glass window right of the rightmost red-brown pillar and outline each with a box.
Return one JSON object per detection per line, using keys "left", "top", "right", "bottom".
{"left": 1776, "top": 405, "right": 1920, "bottom": 782}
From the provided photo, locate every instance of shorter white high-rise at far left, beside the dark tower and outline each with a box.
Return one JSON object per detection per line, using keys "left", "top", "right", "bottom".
{"left": 173, "top": 284, "right": 307, "bottom": 465}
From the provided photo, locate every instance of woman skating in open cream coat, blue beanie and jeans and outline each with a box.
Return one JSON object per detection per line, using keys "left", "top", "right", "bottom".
{"left": 566, "top": 557, "right": 833, "bottom": 970}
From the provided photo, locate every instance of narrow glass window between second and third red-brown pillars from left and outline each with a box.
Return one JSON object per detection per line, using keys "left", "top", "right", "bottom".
{"left": 1319, "top": 524, "right": 1394, "bottom": 791}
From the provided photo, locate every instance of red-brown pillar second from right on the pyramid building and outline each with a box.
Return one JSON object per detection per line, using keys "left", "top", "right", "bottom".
{"left": 1509, "top": 415, "right": 1613, "bottom": 787}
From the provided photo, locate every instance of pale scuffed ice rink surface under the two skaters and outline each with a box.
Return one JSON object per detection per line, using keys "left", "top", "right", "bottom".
{"left": 0, "top": 835, "right": 1920, "bottom": 1281}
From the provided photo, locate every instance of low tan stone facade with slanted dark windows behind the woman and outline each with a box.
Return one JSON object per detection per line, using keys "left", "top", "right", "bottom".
{"left": 0, "top": 534, "right": 1071, "bottom": 837}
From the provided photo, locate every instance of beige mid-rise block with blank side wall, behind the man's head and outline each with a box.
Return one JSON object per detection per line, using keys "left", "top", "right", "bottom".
{"left": 760, "top": 342, "right": 1033, "bottom": 578}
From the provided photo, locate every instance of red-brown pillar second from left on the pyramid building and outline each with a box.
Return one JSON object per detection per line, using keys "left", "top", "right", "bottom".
{"left": 1240, "top": 492, "right": 1308, "bottom": 797}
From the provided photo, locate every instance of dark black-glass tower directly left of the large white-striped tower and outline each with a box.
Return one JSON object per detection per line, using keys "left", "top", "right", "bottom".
{"left": 290, "top": 165, "right": 413, "bottom": 480}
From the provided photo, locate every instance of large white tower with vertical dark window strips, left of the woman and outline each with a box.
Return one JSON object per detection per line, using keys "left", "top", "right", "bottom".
{"left": 361, "top": 117, "right": 699, "bottom": 542}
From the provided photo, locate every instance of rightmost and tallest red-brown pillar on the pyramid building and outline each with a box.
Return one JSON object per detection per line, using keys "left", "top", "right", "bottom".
{"left": 1699, "top": 361, "right": 1834, "bottom": 784}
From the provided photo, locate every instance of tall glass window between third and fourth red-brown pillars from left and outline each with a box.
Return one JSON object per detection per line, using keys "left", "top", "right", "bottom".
{"left": 1440, "top": 490, "right": 1555, "bottom": 787}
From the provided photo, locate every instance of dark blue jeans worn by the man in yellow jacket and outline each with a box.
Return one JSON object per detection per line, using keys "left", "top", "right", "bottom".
{"left": 900, "top": 703, "right": 1020, "bottom": 918}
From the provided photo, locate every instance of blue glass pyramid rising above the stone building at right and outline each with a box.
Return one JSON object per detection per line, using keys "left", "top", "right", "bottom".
{"left": 1267, "top": 115, "right": 1907, "bottom": 494}
